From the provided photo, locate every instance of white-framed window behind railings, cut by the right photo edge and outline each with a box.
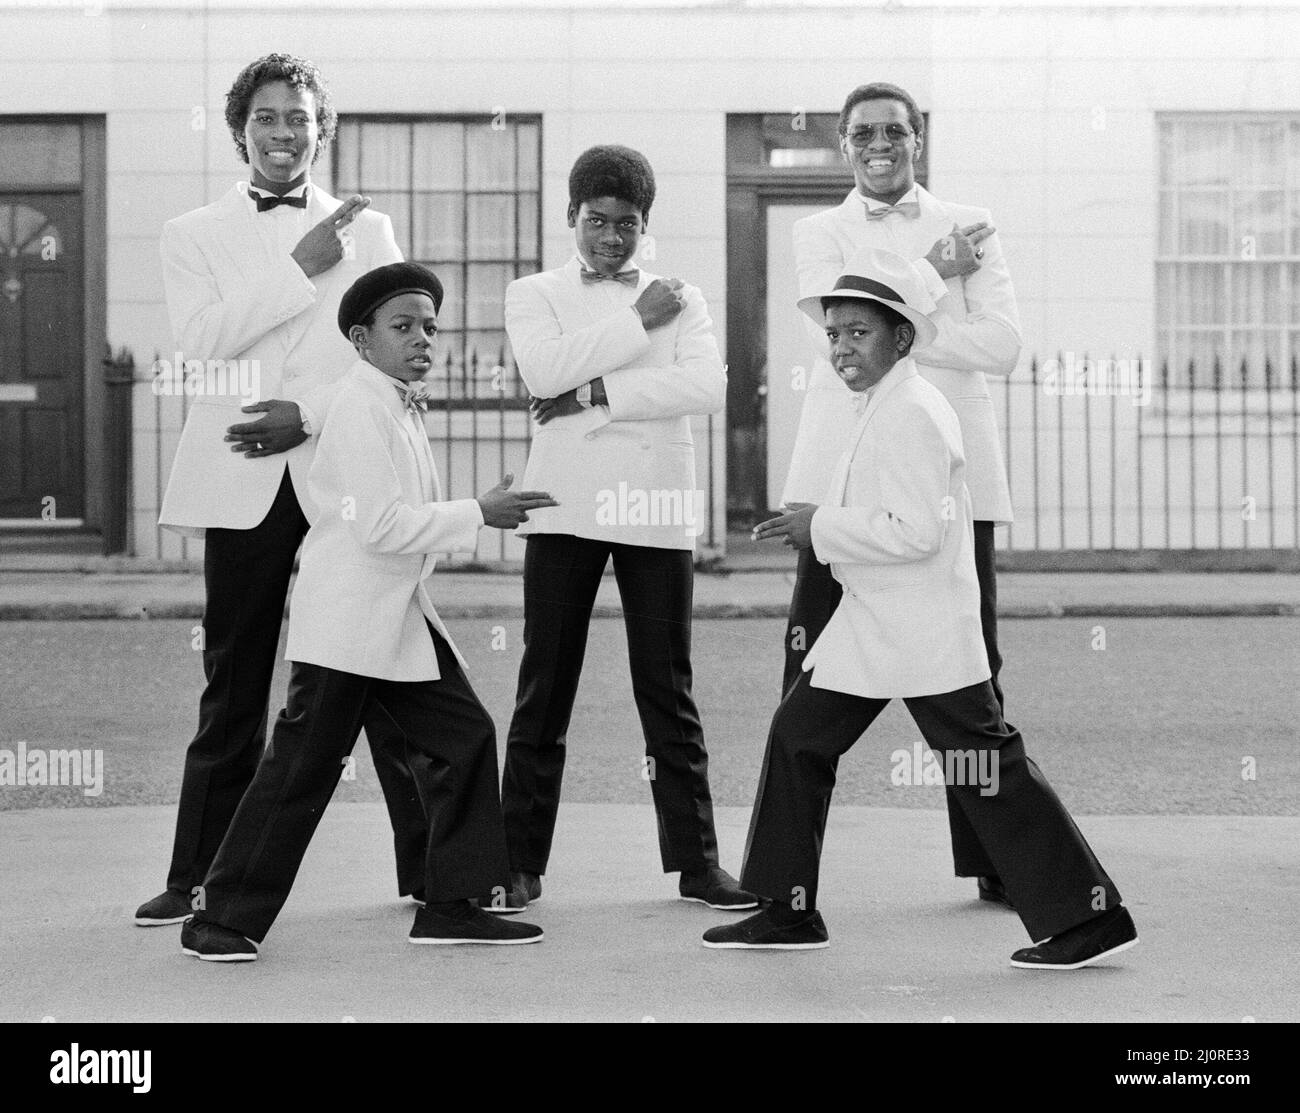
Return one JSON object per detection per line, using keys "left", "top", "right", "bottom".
{"left": 1156, "top": 113, "right": 1300, "bottom": 387}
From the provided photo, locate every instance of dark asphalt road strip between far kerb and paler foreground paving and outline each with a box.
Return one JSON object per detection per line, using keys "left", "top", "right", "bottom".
{"left": 0, "top": 618, "right": 1300, "bottom": 815}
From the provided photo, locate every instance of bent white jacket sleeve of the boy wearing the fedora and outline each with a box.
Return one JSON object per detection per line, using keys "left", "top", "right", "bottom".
{"left": 811, "top": 404, "right": 956, "bottom": 564}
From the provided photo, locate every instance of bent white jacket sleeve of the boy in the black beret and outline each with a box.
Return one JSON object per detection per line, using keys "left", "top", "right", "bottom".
{"left": 312, "top": 406, "right": 484, "bottom": 555}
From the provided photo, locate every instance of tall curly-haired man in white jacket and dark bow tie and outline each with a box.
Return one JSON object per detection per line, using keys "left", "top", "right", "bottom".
{"left": 135, "top": 55, "right": 428, "bottom": 927}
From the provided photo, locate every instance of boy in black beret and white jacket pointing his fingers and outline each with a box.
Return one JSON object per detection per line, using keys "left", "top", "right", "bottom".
{"left": 181, "top": 263, "right": 555, "bottom": 962}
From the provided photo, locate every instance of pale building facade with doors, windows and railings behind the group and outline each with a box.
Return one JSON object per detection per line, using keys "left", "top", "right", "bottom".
{"left": 0, "top": 0, "right": 1300, "bottom": 559}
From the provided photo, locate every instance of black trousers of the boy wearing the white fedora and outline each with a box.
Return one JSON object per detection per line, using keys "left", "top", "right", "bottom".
{"left": 741, "top": 672, "right": 1121, "bottom": 941}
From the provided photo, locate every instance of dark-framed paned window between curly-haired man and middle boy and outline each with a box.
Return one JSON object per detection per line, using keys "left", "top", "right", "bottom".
{"left": 333, "top": 116, "right": 542, "bottom": 406}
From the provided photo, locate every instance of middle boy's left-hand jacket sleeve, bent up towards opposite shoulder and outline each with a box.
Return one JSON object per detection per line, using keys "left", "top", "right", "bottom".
{"left": 506, "top": 278, "right": 650, "bottom": 398}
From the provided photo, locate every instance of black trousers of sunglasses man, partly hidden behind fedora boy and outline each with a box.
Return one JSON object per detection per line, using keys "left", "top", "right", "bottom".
{"left": 781, "top": 521, "right": 1002, "bottom": 878}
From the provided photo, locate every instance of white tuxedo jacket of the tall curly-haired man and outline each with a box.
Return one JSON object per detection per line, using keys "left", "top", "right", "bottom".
{"left": 159, "top": 182, "right": 402, "bottom": 537}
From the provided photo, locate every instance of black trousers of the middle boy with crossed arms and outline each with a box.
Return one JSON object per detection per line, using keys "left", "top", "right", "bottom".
{"left": 501, "top": 533, "right": 718, "bottom": 874}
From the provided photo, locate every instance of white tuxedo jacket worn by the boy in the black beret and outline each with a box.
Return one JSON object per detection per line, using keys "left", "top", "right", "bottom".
{"left": 285, "top": 360, "right": 484, "bottom": 680}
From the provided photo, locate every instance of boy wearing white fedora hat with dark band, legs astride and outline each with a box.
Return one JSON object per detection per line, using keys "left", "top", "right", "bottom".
{"left": 705, "top": 250, "right": 1138, "bottom": 970}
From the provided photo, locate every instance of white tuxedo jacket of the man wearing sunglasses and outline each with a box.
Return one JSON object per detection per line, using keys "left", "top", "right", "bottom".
{"left": 783, "top": 186, "right": 1022, "bottom": 521}
